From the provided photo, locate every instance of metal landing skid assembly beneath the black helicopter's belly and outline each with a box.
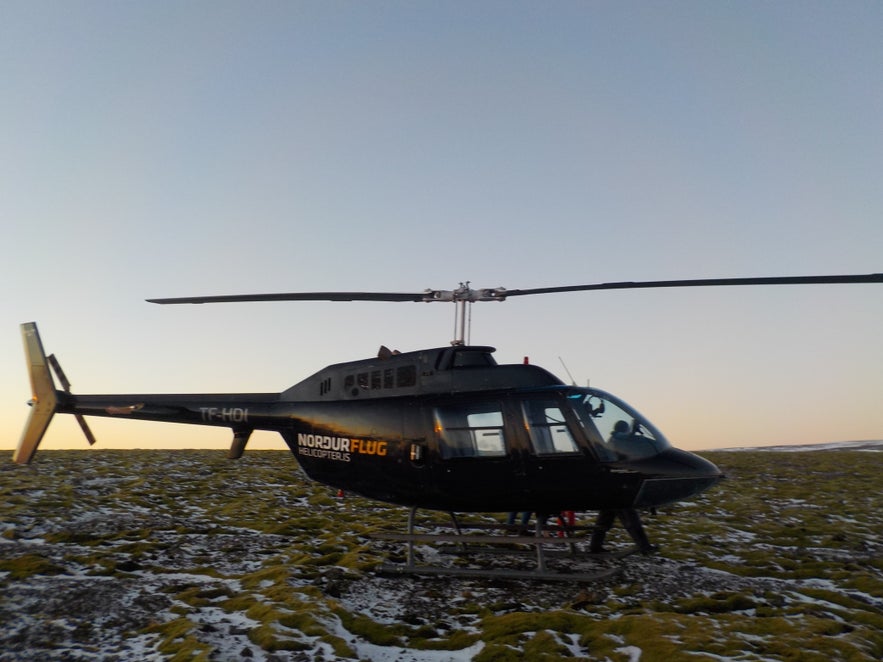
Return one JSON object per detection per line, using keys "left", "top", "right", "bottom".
{"left": 372, "top": 508, "right": 638, "bottom": 581}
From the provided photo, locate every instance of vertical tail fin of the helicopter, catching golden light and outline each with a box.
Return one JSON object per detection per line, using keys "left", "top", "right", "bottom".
{"left": 12, "top": 322, "right": 58, "bottom": 464}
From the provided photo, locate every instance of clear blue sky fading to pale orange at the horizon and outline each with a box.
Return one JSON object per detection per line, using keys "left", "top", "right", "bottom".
{"left": 0, "top": 0, "right": 883, "bottom": 450}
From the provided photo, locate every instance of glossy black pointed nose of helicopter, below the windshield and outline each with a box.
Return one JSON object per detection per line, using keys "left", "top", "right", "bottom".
{"left": 635, "top": 448, "right": 724, "bottom": 508}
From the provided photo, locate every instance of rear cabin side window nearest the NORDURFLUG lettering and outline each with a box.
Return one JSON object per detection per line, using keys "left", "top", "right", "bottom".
{"left": 435, "top": 403, "right": 506, "bottom": 459}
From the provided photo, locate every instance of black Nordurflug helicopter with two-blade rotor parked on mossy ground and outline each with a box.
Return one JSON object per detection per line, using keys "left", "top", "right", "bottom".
{"left": 13, "top": 274, "right": 883, "bottom": 576}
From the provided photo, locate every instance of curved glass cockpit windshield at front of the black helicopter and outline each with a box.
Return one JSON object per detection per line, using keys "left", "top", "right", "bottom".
{"left": 568, "top": 388, "right": 671, "bottom": 462}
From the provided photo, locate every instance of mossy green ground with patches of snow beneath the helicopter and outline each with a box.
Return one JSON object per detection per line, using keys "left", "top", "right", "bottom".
{"left": 0, "top": 451, "right": 883, "bottom": 662}
